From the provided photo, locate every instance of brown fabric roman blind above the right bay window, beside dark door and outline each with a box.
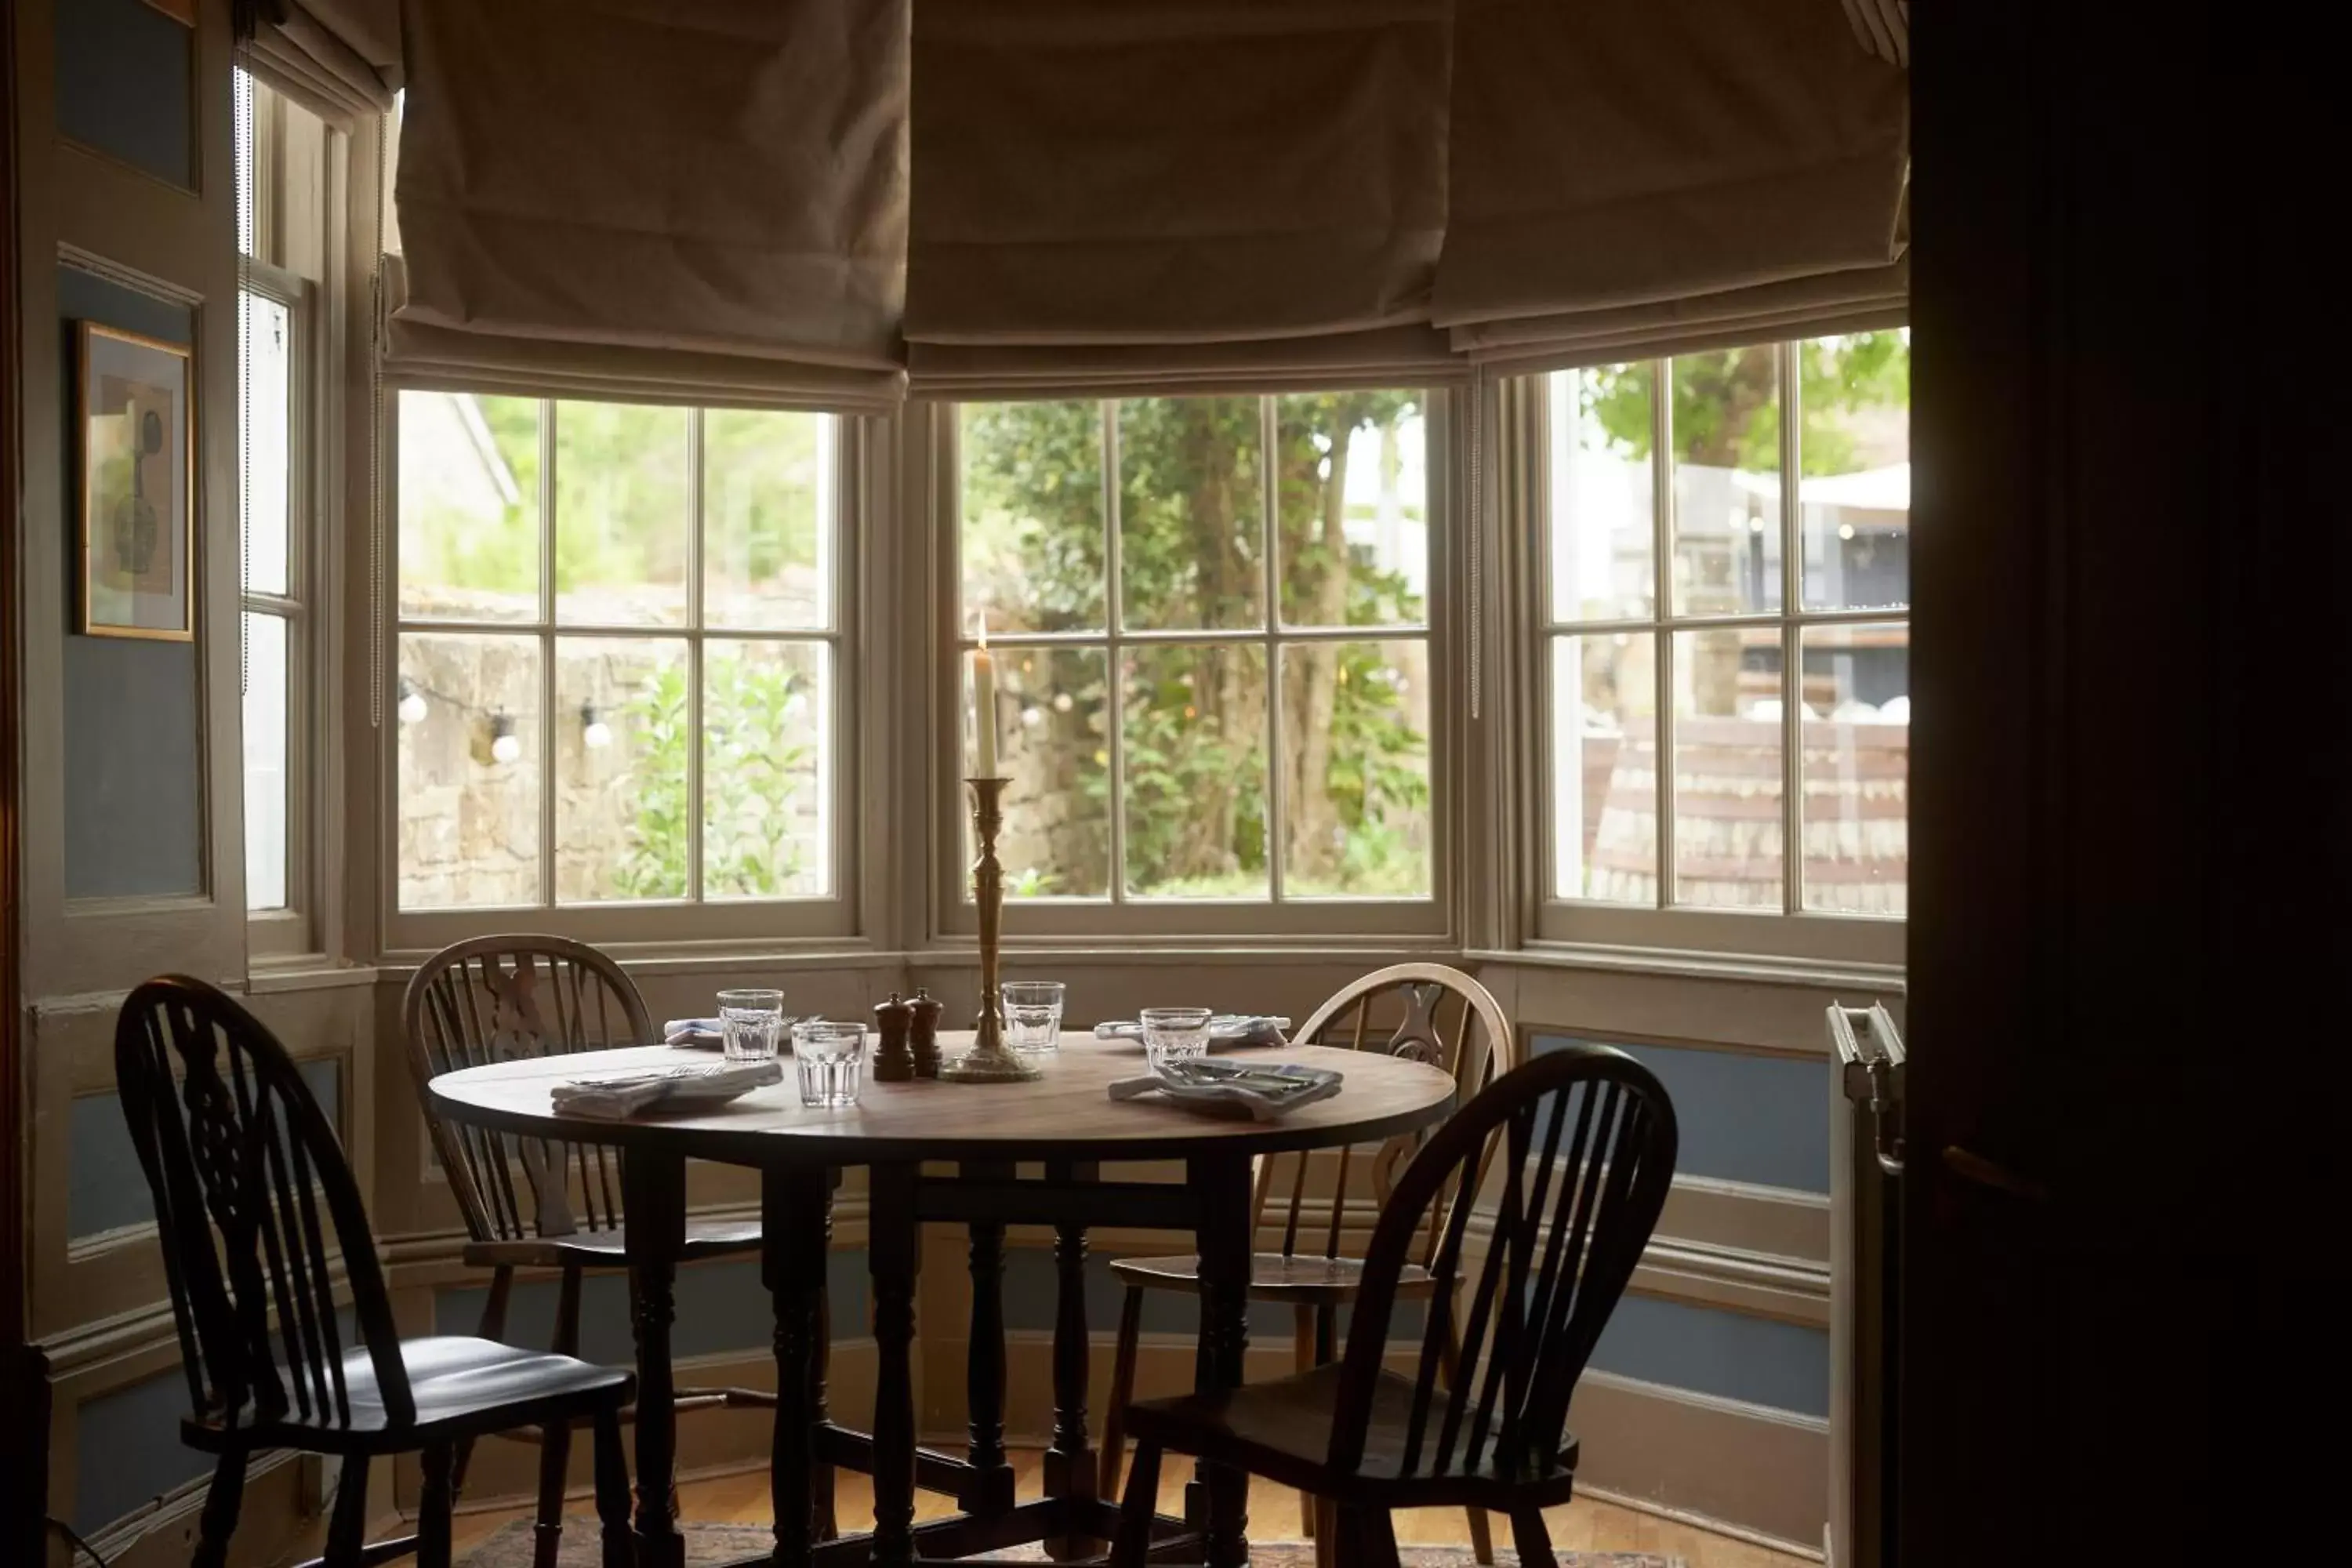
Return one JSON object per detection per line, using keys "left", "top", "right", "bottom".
{"left": 1435, "top": 0, "right": 1910, "bottom": 354}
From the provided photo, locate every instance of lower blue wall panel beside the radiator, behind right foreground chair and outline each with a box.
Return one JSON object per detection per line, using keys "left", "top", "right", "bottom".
{"left": 1592, "top": 1295, "right": 1830, "bottom": 1415}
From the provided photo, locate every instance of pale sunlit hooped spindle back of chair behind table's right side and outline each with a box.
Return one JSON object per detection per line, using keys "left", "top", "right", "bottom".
{"left": 1256, "top": 964, "right": 1517, "bottom": 1262}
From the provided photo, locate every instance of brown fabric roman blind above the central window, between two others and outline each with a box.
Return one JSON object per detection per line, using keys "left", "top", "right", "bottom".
{"left": 906, "top": 0, "right": 1451, "bottom": 390}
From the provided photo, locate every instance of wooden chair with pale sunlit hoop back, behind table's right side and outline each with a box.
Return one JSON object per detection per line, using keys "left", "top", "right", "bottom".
{"left": 1096, "top": 964, "right": 1517, "bottom": 1563}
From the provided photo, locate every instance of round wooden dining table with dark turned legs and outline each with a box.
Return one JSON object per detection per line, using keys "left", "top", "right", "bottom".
{"left": 430, "top": 1034, "right": 1454, "bottom": 1568}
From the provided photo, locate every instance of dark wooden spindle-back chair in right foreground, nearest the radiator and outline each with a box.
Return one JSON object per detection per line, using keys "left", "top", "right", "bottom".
{"left": 1112, "top": 1046, "right": 1675, "bottom": 1568}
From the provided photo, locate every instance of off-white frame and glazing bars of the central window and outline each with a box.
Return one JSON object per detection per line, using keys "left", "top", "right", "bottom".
{"left": 931, "top": 388, "right": 1465, "bottom": 952}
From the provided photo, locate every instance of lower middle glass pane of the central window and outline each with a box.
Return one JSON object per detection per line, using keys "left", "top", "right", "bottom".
{"left": 1122, "top": 647, "right": 1270, "bottom": 898}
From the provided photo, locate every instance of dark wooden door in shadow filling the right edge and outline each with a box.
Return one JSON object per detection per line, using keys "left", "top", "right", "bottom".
{"left": 1898, "top": 0, "right": 2352, "bottom": 1568}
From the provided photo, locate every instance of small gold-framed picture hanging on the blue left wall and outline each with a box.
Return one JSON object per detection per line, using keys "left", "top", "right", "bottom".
{"left": 75, "top": 322, "right": 195, "bottom": 642}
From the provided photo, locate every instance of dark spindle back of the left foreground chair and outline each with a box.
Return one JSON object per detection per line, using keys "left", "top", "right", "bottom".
{"left": 115, "top": 975, "right": 416, "bottom": 1427}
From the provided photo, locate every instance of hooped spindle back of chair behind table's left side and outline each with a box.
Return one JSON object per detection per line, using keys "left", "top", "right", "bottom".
{"left": 400, "top": 935, "right": 659, "bottom": 1241}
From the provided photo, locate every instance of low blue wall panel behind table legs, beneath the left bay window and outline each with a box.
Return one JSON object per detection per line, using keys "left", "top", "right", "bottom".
{"left": 433, "top": 1250, "right": 870, "bottom": 1366}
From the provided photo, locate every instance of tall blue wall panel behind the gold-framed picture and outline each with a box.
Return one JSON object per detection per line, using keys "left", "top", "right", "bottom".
{"left": 56, "top": 267, "right": 205, "bottom": 898}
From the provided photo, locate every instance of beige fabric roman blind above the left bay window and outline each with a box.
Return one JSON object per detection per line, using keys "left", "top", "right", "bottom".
{"left": 386, "top": 0, "right": 908, "bottom": 407}
